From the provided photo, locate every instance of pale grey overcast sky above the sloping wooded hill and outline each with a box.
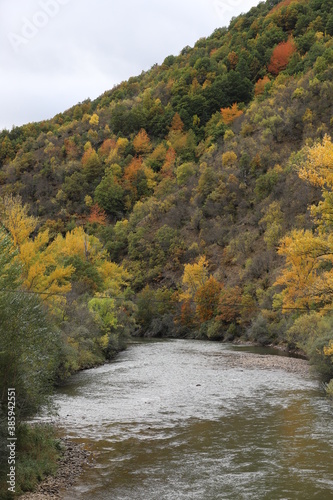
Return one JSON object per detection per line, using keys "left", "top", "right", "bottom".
{"left": 0, "top": 0, "right": 259, "bottom": 129}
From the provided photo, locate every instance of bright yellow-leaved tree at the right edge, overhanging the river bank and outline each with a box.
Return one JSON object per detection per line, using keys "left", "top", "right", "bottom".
{"left": 276, "top": 135, "right": 333, "bottom": 313}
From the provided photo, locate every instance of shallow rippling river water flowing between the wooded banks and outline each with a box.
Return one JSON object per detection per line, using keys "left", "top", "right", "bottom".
{"left": 52, "top": 340, "right": 333, "bottom": 500}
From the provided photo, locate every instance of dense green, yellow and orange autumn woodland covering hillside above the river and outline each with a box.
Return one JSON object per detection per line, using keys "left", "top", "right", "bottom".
{"left": 0, "top": 0, "right": 333, "bottom": 492}
